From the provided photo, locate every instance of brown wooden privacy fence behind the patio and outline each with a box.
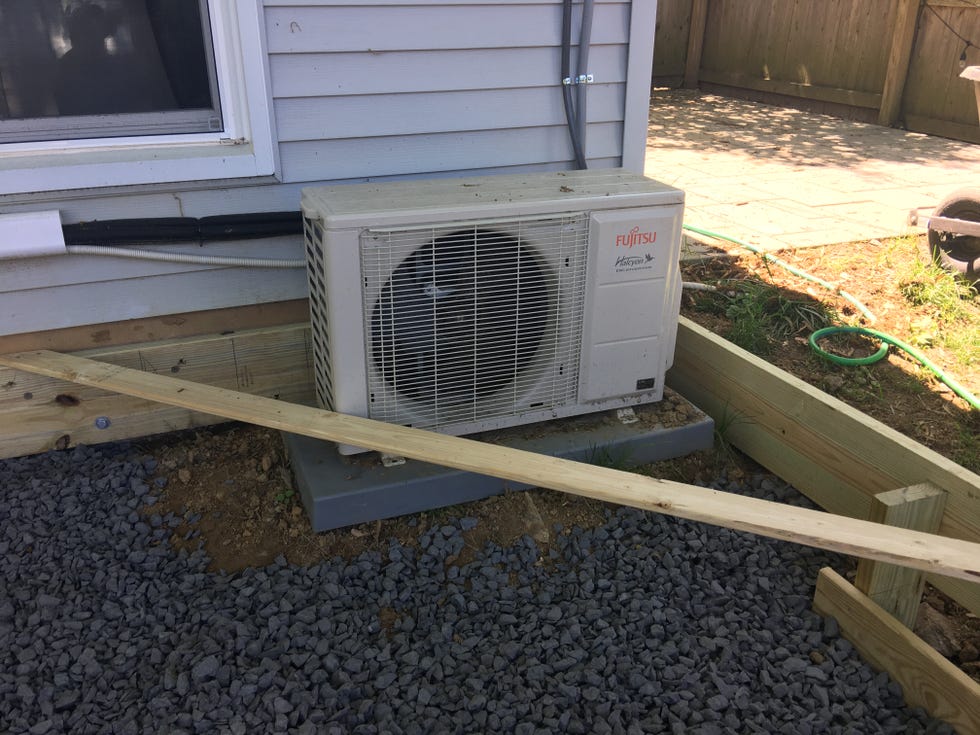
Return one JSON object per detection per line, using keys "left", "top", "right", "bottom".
{"left": 653, "top": 0, "right": 980, "bottom": 143}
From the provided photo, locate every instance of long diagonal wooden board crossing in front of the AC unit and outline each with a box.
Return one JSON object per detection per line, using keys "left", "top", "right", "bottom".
{"left": 0, "top": 350, "right": 980, "bottom": 582}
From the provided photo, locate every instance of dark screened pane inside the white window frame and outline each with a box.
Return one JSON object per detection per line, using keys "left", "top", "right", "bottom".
{"left": 0, "top": 0, "right": 222, "bottom": 143}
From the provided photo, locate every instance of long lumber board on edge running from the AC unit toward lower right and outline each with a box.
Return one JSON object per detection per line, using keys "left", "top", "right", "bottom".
{"left": 667, "top": 317, "right": 980, "bottom": 614}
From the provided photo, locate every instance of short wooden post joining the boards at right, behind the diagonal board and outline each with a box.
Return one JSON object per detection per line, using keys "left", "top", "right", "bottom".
{"left": 854, "top": 483, "right": 946, "bottom": 629}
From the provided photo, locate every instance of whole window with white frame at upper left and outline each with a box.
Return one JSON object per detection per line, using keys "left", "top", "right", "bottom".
{"left": 0, "top": 0, "right": 275, "bottom": 193}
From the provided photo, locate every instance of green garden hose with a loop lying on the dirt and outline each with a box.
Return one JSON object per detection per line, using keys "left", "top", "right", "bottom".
{"left": 683, "top": 225, "right": 980, "bottom": 411}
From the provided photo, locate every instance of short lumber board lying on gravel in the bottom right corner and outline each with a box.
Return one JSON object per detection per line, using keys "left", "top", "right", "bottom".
{"left": 813, "top": 568, "right": 980, "bottom": 733}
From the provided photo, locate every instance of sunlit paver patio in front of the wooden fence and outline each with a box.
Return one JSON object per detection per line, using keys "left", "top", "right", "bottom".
{"left": 645, "top": 90, "right": 980, "bottom": 250}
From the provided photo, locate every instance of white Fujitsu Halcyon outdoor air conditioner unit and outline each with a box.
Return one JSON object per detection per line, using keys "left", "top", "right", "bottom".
{"left": 303, "top": 169, "right": 684, "bottom": 454}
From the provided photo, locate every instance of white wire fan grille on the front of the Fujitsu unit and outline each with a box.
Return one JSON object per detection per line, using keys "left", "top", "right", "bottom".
{"left": 361, "top": 215, "right": 588, "bottom": 428}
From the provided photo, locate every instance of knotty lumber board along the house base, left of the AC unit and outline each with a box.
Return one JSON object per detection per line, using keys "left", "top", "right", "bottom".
{"left": 0, "top": 324, "right": 313, "bottom": 457}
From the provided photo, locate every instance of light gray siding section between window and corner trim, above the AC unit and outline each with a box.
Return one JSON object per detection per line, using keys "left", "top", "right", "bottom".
{"left": 266, "top": 2, "right": 630, "bottom": 182}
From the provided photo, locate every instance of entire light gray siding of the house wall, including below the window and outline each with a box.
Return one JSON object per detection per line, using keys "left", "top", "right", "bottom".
{"left": 0, "top": 0, "right": 656, "bottom": 333}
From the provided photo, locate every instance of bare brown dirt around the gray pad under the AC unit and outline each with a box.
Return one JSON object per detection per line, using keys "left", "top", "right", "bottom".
{"left": 138, "top": 390, "right": 716, "bottom": 572}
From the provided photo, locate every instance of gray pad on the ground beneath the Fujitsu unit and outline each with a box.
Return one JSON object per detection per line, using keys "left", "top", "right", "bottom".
{"left": 284, "top": 393, "right": 714, "bottom": 532}
